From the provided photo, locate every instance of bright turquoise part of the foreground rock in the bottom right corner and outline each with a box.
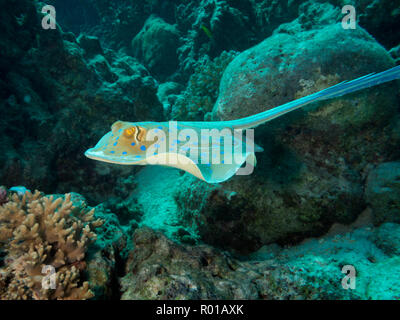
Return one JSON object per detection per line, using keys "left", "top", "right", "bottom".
{"left": 253, "top": 220, "right": 400, "bottom": 299}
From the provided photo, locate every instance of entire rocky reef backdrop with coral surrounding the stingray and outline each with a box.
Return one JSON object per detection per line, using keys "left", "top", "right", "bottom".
{"left": 0, "top": 0, "right": 400, "bottom": 300}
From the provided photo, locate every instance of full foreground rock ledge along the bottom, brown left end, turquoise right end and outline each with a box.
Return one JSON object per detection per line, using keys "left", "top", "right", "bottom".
{"left": 121, "top": 223, "right": 400, "bottom": 300}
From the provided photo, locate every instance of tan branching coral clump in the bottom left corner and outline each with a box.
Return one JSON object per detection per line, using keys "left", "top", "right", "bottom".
{"left": 0, "top": 191, "right": 102, "bottom": 300}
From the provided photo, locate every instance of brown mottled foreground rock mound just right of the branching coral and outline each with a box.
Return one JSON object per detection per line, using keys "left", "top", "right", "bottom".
{"left": 121, "top": 228, "right": 330, "bottom": 300}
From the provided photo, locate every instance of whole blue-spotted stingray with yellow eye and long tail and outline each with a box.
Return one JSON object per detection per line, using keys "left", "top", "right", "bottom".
{"left": 85, "top": 66, "right": 400, "bottom": 183}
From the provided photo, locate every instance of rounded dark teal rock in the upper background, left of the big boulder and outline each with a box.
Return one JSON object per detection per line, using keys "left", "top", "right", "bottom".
{"left": 132, "top": 16, "right": 179, "bottom": 76}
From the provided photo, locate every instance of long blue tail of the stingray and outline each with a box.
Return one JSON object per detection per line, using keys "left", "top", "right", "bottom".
{"left": 227, "top": 66, "right": 400, "bottom": 129}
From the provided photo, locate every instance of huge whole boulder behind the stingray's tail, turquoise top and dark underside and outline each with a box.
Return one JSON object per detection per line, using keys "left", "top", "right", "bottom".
{"left": 176, "top": 19, "right": 399, "bottom": 252}
